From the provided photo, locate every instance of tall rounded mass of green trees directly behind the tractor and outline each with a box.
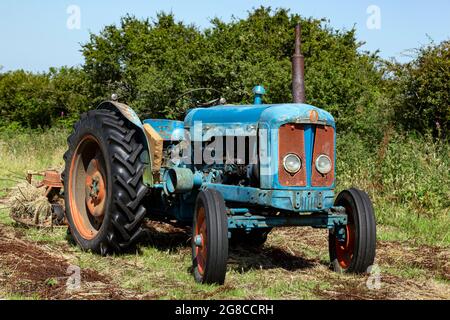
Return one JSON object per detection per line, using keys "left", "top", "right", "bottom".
{"left": 83, "top": 7, "right": 382, "bottom": 136}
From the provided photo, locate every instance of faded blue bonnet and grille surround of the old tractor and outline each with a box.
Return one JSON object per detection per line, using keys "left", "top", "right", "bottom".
{"left": 185, "top": 104, "right": 336, "bottom": 194}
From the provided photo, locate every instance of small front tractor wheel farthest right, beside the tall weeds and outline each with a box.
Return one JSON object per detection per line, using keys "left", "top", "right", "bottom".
{"left": 329, "top": 189, "right": 377, "bottom": 274}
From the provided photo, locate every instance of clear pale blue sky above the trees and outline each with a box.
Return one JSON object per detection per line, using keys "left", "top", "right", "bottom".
{"left": 0, "top": 0, "right": 450, "bottom": 71}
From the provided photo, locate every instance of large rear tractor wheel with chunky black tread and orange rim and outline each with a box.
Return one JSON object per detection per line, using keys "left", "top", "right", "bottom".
{"left": 64, "top": 110, "right": 148, "bottom": 255}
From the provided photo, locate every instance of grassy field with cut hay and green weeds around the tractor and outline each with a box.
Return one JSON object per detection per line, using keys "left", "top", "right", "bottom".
{"left": 0, "top": 129, "right": 450, "bottom": 299}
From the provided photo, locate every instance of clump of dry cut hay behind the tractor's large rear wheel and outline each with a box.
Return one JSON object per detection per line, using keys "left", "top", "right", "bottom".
{"left": 7, "top": 182, "right": 52, "bottom": 227}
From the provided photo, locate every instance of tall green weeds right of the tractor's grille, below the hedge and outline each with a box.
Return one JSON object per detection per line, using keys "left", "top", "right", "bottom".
{"left": 337, "top": 131, "right": 450, "bottom": 218}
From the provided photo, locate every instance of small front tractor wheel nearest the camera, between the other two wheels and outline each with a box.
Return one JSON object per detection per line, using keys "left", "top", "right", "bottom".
{"left": 192, "top": 190, "right": 228, "bottom": 284}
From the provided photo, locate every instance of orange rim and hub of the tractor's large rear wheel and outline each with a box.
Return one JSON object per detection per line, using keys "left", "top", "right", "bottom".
{"left": 68, "top": 135, "right": 107, "bottom": 240}
